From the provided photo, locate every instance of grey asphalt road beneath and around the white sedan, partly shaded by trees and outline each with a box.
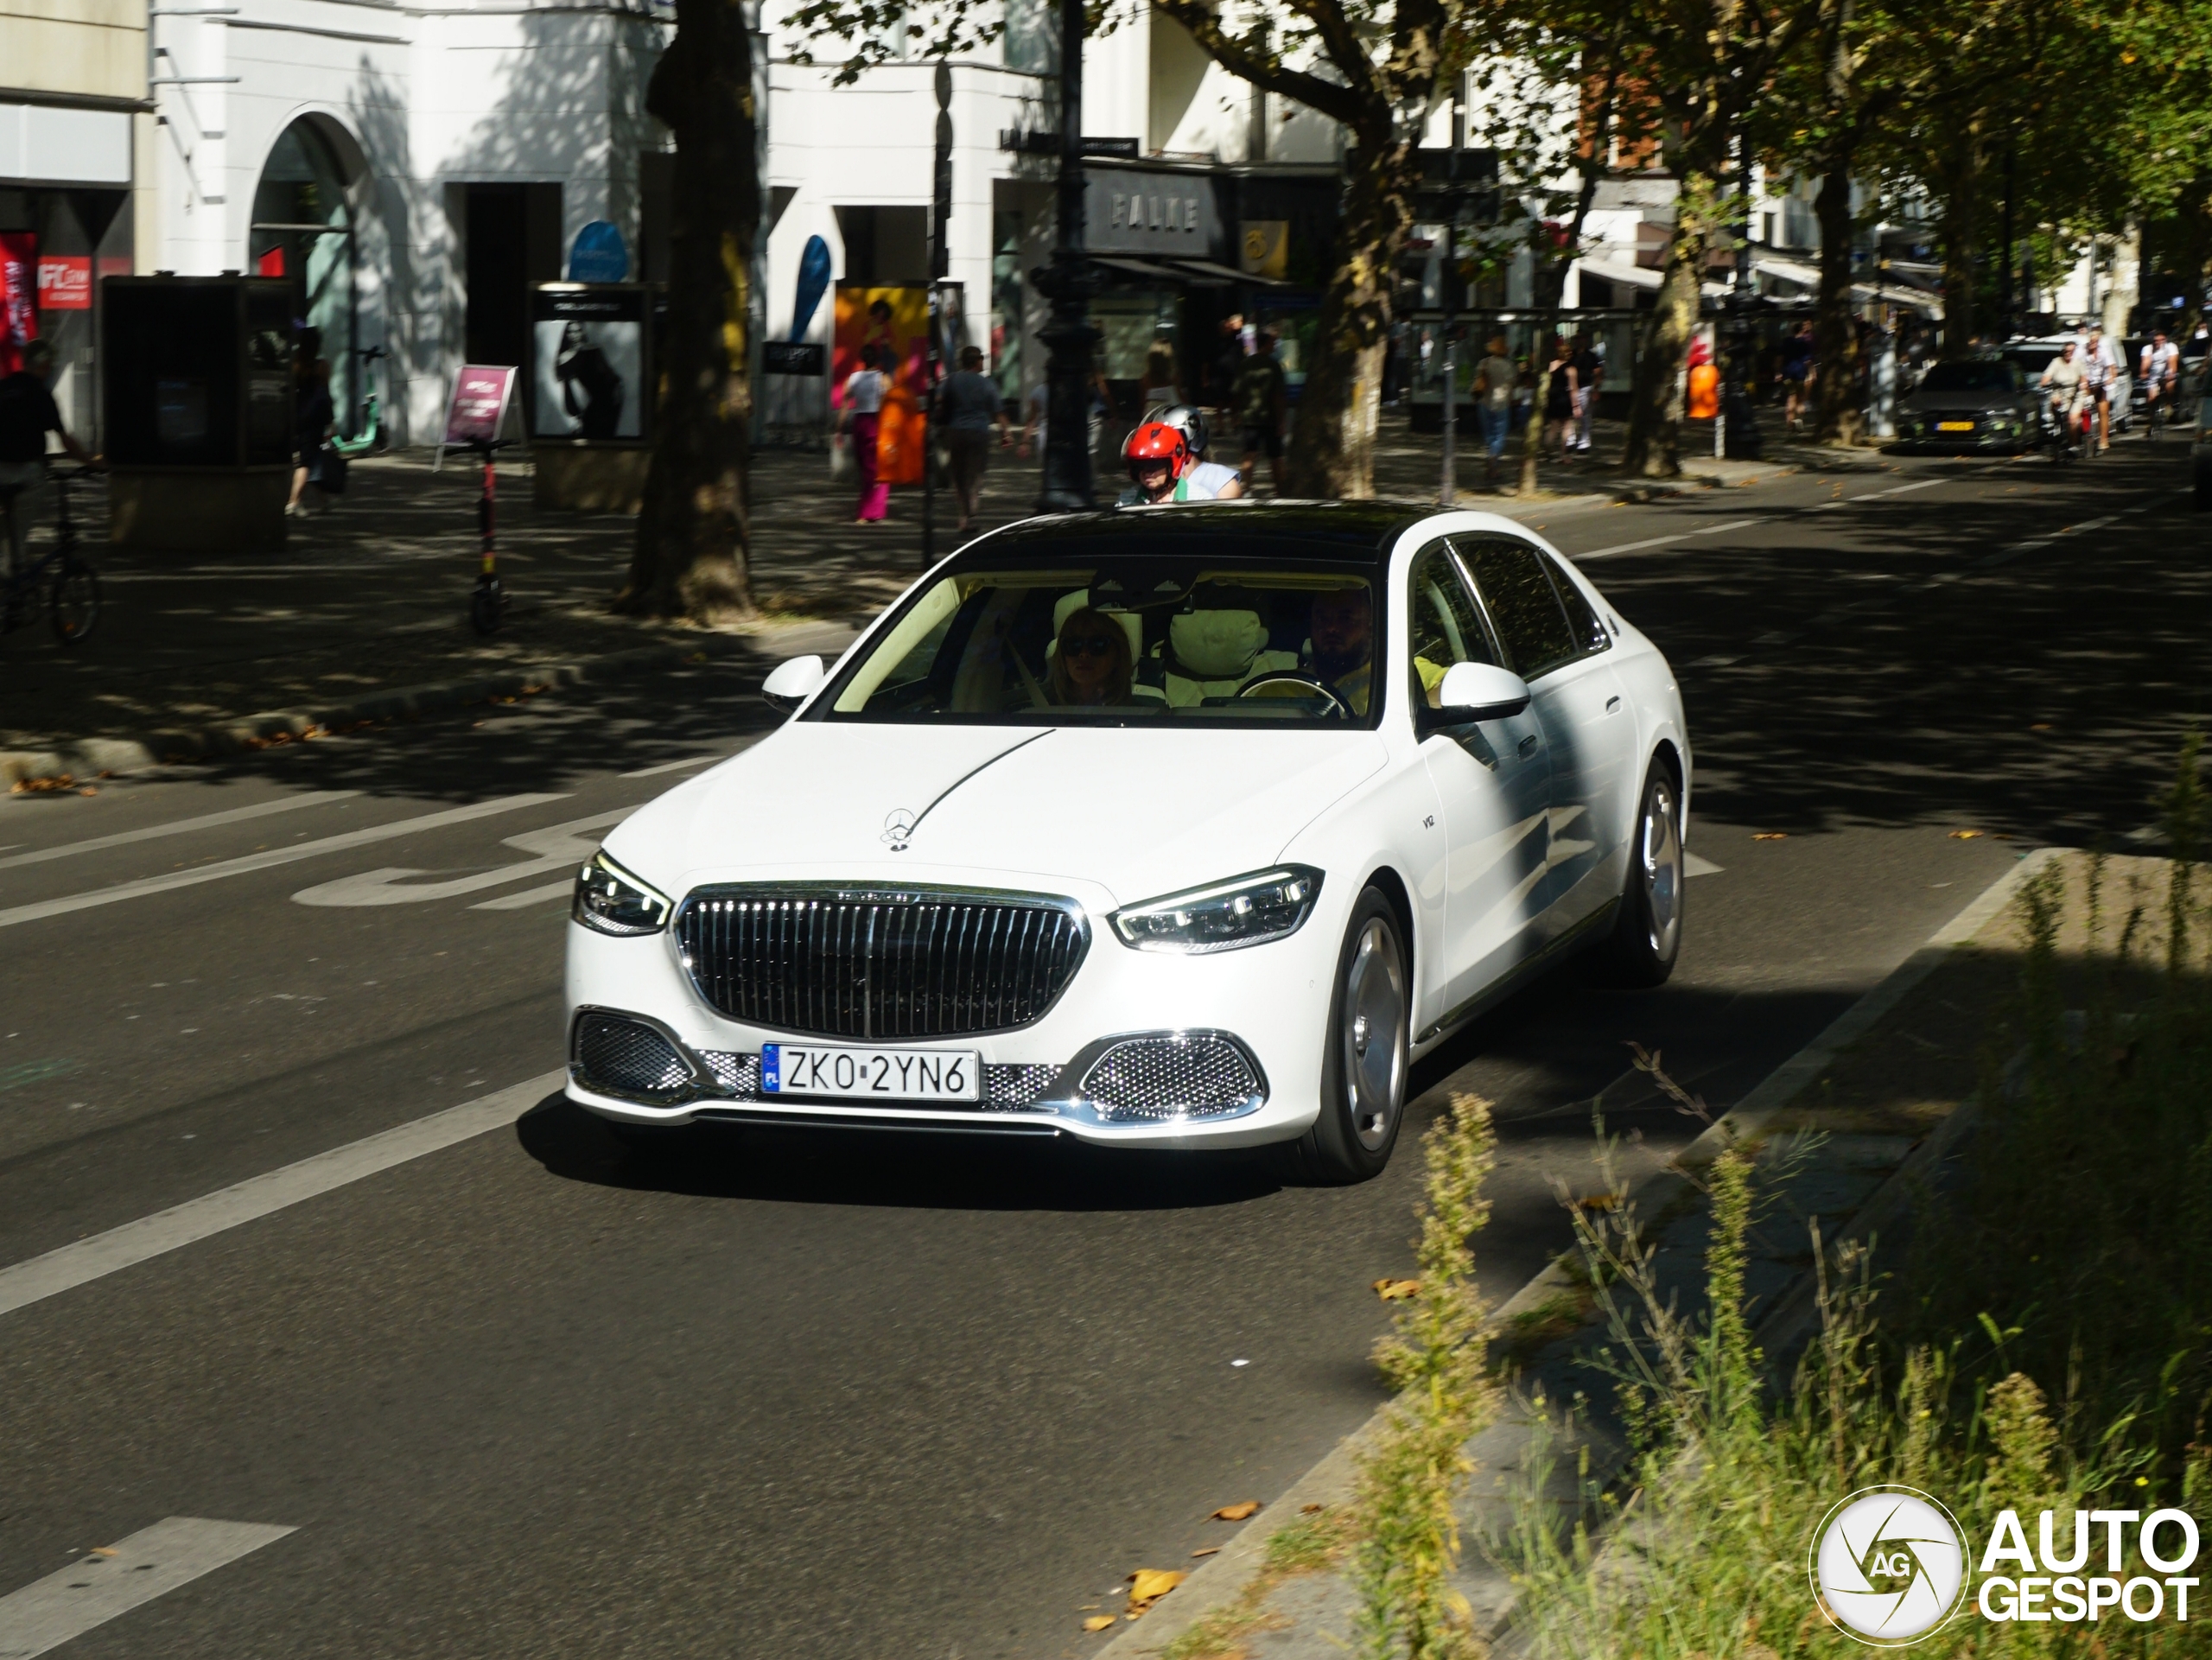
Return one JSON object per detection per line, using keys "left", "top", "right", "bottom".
{"left": 0, "top": 436, "right": 2212, "bottom": 1660}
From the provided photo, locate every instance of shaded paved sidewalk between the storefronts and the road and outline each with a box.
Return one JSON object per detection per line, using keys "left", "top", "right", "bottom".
{"left": 0, "top": 411, "right": 1873, "bottom": 784}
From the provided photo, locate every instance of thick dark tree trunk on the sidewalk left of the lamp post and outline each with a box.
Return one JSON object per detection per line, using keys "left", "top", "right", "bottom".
{"left": 615, "top": 0, "right": 761, "bottom": 624}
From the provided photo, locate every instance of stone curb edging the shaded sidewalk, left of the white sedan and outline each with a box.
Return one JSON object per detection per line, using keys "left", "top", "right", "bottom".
{"left": 0, "top": 624, "right": 849, "bottom": 785}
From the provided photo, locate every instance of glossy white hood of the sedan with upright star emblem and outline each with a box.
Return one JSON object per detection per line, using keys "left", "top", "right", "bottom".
{"left": 606, "top": 722, "right": 1385, "bottom": 906}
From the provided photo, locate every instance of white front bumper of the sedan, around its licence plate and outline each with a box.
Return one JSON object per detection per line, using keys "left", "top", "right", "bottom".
{"left": 569, "top": 890, "right": 1343, "bottom": 1148}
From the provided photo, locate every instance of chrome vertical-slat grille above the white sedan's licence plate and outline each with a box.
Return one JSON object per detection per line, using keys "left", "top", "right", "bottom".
{"left": 677, "top": 887, "right": 1090, "bottom": 1040}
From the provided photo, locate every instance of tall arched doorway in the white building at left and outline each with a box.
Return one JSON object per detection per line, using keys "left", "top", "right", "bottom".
{"left": 250, "top": 115, "right": 360, "bottom": 436}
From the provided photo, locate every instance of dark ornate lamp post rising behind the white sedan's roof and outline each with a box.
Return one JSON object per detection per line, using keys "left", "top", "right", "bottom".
{"left": 1028, "top": 0, "right": 1099, "bottom": 513}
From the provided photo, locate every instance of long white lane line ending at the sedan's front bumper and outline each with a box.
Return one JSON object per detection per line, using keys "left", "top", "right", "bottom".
{"left": 0, "top": 1072, "right": 569, "bottom": 1314}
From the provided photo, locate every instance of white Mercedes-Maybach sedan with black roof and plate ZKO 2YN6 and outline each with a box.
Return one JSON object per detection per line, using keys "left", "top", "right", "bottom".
{"left": 569, "top": 502, "right": 1690, "bottom": 1182}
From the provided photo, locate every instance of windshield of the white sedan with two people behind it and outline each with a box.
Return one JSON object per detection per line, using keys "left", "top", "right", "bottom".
{"left": 814, "top": 560, "right": 1382, "bottom": 730}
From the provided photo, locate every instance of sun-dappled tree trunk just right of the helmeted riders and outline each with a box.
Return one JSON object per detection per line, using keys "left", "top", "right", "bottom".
{"left": 1283, "top": 124, "right": 1414, "bottom": 500}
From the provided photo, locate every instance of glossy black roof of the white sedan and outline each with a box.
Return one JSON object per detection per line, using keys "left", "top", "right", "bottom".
{"left": 964, "top": 500, "right": 1435, "bottom": 563}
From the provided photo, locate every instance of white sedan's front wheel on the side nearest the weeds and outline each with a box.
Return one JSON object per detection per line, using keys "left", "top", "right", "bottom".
{"left": 1283, "top": 887, "right": 1414, "bottom": 1186}
